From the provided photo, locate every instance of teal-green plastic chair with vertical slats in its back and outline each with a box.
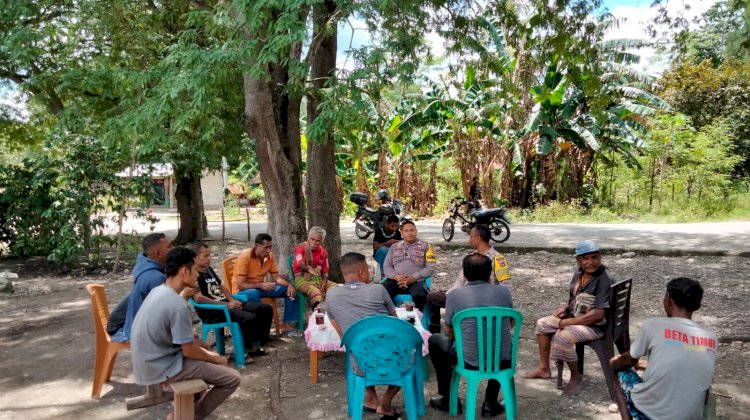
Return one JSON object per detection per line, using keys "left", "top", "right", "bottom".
{"left": 448, "top": 306, "right": 523, "bottom": 419}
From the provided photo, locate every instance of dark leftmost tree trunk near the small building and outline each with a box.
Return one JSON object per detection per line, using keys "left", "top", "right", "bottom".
{"left": 173, "top": 166, "right": 208, "bottom": 245}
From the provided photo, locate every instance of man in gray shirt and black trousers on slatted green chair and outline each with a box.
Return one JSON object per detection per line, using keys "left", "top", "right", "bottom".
{"left": 429, "top": 253, "right": 513, "bottom": 417}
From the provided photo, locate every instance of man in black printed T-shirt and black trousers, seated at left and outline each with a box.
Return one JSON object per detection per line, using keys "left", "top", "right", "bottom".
{"left": 183, "top": 242, "right": 273, "bottom": 356}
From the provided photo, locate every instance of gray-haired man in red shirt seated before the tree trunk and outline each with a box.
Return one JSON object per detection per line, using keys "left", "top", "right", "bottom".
{"left": 292, "top": 226, "right": 336, "bottom": 309}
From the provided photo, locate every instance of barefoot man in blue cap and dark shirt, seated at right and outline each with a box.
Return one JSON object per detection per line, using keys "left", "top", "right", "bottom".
{"left": 523, "top": 241, "right": 614, "bottom": 395}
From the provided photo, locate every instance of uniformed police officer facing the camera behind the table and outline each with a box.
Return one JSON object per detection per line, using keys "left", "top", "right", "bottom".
{"left": 382, "top": 220, "right": 437, "bottom": 309}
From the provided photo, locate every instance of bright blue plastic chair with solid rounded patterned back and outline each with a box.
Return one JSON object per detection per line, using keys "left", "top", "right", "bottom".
{"left": 341, "top": 315, "right": 424, "bottom": 420}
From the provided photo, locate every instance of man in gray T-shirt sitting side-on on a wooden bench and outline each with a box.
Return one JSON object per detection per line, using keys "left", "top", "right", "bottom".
{"left": 130, "top": 247, "right": 240, "bottom": 419}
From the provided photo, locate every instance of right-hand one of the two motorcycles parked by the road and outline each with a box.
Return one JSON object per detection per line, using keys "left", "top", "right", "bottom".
{"left": 443, "top": 197, "right": 510, "bottom": 243}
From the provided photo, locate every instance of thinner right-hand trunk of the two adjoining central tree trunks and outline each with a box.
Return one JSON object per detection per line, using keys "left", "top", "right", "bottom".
{"left": 307, "top": 0, "right": 342, "bottom": 280}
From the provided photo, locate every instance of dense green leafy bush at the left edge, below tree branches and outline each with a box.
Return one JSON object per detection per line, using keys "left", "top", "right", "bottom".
{"left": 0, "top": 137, "right": 153, "bottom": 264}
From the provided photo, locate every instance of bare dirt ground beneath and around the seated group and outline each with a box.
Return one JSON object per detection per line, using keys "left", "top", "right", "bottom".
{"left": 0, "top": 241, "right": 750, "bottom": 419}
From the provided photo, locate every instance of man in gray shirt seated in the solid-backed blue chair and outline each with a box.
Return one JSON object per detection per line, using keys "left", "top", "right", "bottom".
{"left": 325, "top": 252, "right": 400, "bottom": 419}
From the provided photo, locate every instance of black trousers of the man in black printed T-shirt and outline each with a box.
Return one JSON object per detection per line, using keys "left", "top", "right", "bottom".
{"left": 198, "top": 302, "right": 273, "bottom": 348}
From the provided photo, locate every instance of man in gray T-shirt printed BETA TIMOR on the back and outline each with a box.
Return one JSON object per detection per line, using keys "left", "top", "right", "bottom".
{"left": 611, "top": 277, "right": 719, "bottom": 420}
